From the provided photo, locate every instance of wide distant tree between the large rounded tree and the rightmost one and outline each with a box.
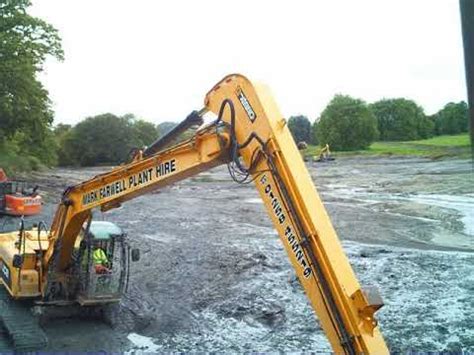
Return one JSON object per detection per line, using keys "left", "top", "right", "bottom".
{"left": 370, "top": 98, "right": 434, "bottom": 141}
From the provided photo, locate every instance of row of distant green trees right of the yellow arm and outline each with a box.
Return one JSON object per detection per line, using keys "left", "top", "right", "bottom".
{"left": 288, "top": 95, "right": 469, "bottom": 150}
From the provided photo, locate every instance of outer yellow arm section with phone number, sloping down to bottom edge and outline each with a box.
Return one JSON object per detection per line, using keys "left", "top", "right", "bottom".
{"left": 205, "top": 75, "right": 388, "bottom": 353}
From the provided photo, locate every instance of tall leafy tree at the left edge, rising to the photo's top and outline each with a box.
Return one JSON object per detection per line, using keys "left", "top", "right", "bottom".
{"left": 0, "top": 0, "right": 63, "bottom": 162}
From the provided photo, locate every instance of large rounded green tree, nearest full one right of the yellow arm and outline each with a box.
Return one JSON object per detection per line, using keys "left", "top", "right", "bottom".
{"left": 317, "top": 95, "right": 378, "bottom": 150}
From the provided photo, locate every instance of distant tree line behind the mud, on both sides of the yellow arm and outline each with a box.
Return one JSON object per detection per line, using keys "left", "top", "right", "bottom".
{"left": 58, "top": 95, "right": 468, "bottom": 166}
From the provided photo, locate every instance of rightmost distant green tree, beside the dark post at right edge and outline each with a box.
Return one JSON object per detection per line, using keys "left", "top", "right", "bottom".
{"left": 434, "top": 101, "right": 469, "bottom": 134}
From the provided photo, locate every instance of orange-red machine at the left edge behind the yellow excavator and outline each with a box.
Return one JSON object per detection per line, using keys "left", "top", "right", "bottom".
{"left": 0, "top": 168, "right": 42, "bottom": 216}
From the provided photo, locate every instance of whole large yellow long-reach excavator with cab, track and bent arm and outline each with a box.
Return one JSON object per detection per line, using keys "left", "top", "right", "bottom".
{"left": 0, "top": 74, "right": 388, "bottom": 354}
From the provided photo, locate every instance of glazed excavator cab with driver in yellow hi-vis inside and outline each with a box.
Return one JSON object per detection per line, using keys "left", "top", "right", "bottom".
{"left": 74, "top": 221, "right": 132, "bottom": 305}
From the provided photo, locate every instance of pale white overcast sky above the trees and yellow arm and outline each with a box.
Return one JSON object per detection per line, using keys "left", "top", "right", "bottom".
{"left": 31, "top": 0, "right": 466, "bottom": 123}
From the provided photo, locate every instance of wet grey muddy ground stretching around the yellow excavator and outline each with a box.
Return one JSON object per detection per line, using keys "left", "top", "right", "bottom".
{"left": 1, "top": 157, "right": 474, "bottom": 352}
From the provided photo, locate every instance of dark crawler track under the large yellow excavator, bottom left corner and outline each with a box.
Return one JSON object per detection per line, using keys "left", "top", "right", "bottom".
{"left": 0, "top": 286, "right": 48, "bottom": 352}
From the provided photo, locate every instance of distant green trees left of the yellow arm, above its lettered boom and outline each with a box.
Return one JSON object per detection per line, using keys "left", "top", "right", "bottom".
{"left": 55, "top": 113, "right": 158, "bottom": 166}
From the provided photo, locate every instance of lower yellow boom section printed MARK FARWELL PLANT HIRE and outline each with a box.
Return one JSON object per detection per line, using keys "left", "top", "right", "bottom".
{"left": 44, "top": 128, "right": 228, "bottom": 274}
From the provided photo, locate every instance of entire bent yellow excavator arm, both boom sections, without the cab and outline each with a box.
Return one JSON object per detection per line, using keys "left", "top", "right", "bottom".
{"left": 43, "top": 74, "right": 388, "bottom": 354}
